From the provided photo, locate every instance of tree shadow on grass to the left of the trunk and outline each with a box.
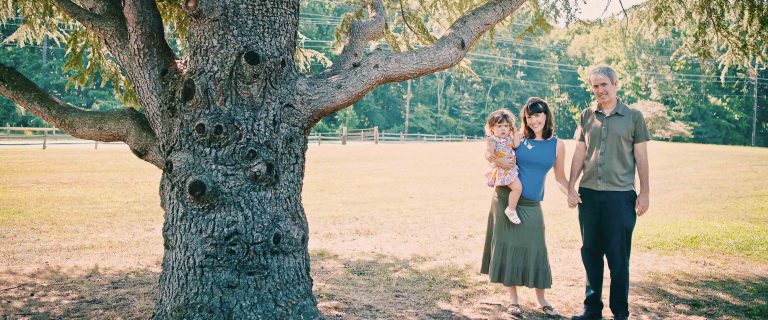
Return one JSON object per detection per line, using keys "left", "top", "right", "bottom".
{"left": 0, "top": 267, "right": 159, "bottom": 320}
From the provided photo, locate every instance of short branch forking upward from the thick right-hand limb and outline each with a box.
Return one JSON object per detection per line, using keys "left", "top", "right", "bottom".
{"left": 329, "top": 0, "right": 387, "bottom": 74}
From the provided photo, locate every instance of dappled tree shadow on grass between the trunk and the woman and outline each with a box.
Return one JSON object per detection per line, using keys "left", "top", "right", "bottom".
{"left": 312, "top": 251, "right": 551, "bottom": 319}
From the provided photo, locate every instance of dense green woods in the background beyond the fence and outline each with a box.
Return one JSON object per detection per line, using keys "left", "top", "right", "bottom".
{"left": 0, "top": 1, "right": 768, "bottom": 146}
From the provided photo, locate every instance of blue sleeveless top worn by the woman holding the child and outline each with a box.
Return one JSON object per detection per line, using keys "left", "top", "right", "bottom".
{"left": 515, "top": 137, "right": 557, "bottom": 201}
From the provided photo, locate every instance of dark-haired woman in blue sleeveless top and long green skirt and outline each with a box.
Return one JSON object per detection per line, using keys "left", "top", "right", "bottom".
{"left": 480, "top": 98, "right": 568, "bottom": 316}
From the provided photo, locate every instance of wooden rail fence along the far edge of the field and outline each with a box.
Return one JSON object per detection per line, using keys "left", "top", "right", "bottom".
{"left": 0, "top": 126, "right": 483, "bottom": 149}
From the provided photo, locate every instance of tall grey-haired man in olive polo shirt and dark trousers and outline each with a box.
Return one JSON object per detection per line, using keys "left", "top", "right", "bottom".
{"left": 568, "top": 66, "right": 651, "bottom": 320}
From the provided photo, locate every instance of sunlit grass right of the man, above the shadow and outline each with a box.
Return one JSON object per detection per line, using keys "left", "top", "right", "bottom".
{"left": 636, "top": 143, "right": 768, "bottom": 262}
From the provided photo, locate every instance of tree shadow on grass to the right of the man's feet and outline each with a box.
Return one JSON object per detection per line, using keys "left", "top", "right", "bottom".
{"left": 633, "top": 273, "right": 768, "bottom": 319}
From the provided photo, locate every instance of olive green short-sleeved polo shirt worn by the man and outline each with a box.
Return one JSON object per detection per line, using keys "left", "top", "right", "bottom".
{"left": 576, "top": 100, "right": 651, "bottom": 191}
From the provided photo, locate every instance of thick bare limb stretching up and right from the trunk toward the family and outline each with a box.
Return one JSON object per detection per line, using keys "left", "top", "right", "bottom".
{"left": 297, "top": 0, "right": 526, "bottom": 125}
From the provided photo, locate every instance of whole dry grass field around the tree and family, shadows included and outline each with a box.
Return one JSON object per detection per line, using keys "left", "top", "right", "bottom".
{"left": 0, "top": 141, "right": 768, "bottom": 319}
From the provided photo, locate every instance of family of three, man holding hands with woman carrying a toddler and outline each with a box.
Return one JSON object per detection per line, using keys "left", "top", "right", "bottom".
{"left": 481, "top": 66, "right": 650, "bottom": 319}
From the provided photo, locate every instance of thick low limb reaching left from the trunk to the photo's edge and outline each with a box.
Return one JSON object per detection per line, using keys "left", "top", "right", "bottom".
{"left": 0, "top": 64, "right": 163, "bottom": 168}
